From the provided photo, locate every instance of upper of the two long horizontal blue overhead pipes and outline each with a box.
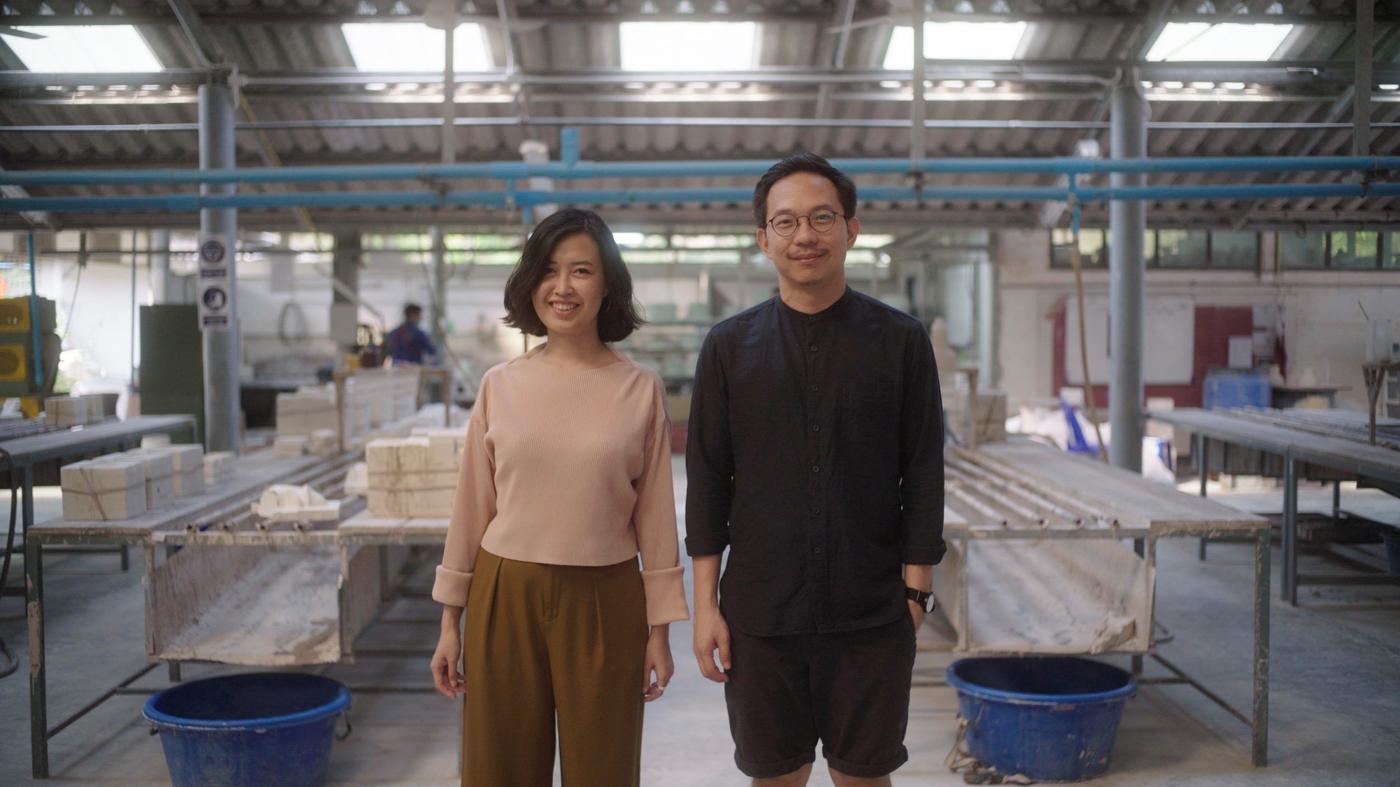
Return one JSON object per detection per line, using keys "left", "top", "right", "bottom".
{"left": 0, "top": 153, "right": 1400, "bottom": 188}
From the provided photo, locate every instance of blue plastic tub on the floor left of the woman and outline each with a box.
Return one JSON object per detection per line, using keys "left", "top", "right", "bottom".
{"left": 143, "top": 672, "right": 350, "bottom": 787}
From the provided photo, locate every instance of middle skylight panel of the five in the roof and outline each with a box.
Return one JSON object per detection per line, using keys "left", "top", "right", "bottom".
{"left": 617, "top": 22, "right": 759, "bottom": 71}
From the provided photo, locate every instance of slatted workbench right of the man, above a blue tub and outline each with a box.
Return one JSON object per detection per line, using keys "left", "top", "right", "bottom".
{"left": 935, "top": 440, "right": 1270, "bottom": 766}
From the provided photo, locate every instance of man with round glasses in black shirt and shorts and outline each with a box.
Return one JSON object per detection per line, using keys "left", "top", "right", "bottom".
{"left": 686, "top": 154, "right": 944, "bottom": 787}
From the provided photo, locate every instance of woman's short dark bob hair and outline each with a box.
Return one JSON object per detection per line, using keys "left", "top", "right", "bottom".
{"left": 504, "top": 207, "right": 643, "bottom": 342}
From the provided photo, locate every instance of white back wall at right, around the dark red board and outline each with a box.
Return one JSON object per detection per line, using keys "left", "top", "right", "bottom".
{"left": 995, "top": 230, "right": 1400, "bottom": 409}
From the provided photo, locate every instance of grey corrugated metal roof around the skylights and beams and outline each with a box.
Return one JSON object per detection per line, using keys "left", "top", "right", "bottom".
{"left": 0, "top": 0, "right": 1400, "bottom": 225}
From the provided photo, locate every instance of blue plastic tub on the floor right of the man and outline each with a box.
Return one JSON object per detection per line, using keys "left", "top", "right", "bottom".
{"left": 948, "top": 657, "right": 1137, "bottom": 781}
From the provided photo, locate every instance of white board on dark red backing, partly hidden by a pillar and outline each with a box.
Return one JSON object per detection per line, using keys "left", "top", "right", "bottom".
{"left": 1064, "top": 295, "right": 1196, "bottom": 385}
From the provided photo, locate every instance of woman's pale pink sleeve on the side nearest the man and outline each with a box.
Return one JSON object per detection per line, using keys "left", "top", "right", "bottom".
{"left": 631, "top": 378, "right": 690, "bottom": 626}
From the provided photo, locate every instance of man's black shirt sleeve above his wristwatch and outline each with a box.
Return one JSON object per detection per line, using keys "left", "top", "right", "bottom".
{"left": 899, "top": 324, "right": 946, "bottom": 566}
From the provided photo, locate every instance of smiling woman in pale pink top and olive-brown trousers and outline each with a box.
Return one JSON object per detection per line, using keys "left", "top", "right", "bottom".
{"left": 431, "top": 209, "right": 689, "bottom": 787}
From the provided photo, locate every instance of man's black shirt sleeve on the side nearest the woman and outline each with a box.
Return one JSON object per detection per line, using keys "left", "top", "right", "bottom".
{"left": 686, "top": 330, "right": 734, "bottom": 557}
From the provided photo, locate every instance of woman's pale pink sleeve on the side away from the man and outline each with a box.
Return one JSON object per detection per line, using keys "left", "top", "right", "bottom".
{"left": 433, "top": 375, "right": 496, "bottom": 606}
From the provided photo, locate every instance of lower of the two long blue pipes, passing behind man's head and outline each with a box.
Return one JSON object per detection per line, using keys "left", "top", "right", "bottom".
{"left": 10, "top": 183, "right": 1400, "bottom": 213}
